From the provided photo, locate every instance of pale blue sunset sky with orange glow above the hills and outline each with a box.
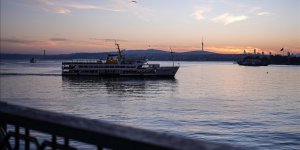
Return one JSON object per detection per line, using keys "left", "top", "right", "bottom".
{"left": 1, "top": 0, "right": 300, "bottom": 54}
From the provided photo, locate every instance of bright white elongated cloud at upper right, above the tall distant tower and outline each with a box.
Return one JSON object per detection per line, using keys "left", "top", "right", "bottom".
{"left": 212, "top": 13, "right": 248, "bottom": 25}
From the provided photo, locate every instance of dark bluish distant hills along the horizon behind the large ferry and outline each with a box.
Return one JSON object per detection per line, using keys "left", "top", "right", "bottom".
{"left": 0, "top": 49, "right": 240, "bottom": 61}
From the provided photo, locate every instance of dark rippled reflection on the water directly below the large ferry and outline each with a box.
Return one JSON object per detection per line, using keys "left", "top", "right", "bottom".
{"left": 62, "top": 76, "right": 177, "bottom": 100}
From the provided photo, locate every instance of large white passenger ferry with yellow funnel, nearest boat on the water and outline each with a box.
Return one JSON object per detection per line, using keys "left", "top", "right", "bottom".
{"left": 62, "top": 43, "right": 179, "bottom": 77}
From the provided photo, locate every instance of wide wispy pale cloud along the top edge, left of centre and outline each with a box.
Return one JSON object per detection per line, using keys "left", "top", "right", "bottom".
{"left": 11, "top": 0, "right": 154, "bottom": 22}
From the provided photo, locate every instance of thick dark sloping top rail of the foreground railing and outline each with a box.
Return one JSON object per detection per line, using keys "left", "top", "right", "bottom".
{"left": 0, "top": 102, "right": 236, "bottom": 150}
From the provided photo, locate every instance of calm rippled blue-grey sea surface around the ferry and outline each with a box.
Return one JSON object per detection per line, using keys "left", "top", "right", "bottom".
{"left": 0, "top": 60, "right": 300, "bottom": 150}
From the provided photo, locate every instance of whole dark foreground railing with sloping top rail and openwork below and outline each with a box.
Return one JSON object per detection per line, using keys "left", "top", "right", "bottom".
{"left": 0, "top": 102, "right": 236, "bottom": 150}
